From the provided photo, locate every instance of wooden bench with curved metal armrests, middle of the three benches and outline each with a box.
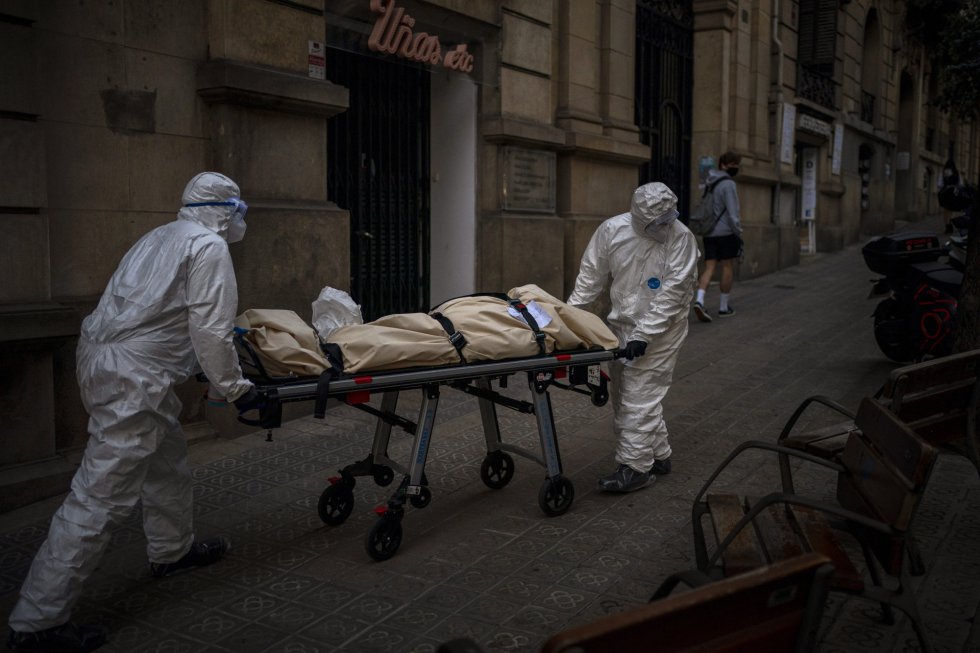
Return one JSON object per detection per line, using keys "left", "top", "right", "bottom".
{"left": 692, "top": 398, "right": 937, "bottom": 651}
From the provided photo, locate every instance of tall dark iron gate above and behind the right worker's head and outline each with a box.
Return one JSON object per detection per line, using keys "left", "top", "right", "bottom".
{"left": 636, "top": 0, "right": 694, "bottom": 221}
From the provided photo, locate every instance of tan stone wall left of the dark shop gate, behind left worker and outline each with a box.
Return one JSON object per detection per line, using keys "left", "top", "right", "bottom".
{"left": 0, "top": 0, "right": 348, "bottom": 510}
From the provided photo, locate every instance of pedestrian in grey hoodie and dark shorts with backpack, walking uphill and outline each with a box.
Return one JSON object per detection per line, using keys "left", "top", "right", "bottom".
{"left": 694, "top": 152, "right": 742, "bottom": 322}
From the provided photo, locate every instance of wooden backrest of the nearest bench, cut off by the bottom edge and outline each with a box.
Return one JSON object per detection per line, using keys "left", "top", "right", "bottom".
{"left": 438, "top": 553, "right": 832, "bottom": 653}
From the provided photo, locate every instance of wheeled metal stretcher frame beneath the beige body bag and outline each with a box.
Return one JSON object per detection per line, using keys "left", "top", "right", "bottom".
{"left": 236, "top": 338, "right": 617, "bottom": 560}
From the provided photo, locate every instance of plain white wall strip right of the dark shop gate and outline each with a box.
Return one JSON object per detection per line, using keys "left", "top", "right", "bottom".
{"left": 429, "top": 71, "right": 477, "bottom": 306}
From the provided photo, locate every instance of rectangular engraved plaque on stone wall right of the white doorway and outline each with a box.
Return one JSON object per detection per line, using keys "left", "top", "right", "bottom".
{"left": 500, "top": 147, "right": 557, "bottom": 213}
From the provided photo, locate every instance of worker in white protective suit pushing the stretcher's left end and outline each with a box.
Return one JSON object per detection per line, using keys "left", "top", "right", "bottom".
{"left": 7, "top": 172, "right": 260, "bottom": 651}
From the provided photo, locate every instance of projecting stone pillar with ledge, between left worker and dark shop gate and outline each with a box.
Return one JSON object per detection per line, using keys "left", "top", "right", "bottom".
{"left": 196, "top": 0, "right": 350, "bottom": 435}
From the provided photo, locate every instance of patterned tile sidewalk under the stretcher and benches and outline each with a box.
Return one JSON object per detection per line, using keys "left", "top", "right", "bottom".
{"left": 0, "top": 220, "right": 980, "bottom": 653}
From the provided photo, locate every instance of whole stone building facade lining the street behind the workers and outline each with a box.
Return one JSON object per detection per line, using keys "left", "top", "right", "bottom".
{"left": 0, "top": 0, "right": 980, "bottom": 510}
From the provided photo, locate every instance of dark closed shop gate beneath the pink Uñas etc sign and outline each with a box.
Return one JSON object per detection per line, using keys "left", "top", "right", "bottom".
{"left": 326, "top": 48, "right": 429, "bottom": 321}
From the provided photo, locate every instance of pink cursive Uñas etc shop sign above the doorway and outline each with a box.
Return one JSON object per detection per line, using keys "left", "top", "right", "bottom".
{"left": 368, "top": 0, "right": 473, "bottom": 73}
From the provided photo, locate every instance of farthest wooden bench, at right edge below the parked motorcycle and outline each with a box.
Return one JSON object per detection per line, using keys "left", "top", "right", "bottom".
{"left": 776, "top": 349, "right": 980, "bottom": 492}
